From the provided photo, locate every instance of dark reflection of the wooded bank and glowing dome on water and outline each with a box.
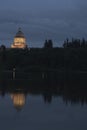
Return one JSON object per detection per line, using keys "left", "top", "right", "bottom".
{"left": 0, "top": 72, "right": 87, "bottom": 110}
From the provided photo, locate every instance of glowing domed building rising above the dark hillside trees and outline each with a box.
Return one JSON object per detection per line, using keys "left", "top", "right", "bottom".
{"left": 11, "top": 28, "right": 27, "bottom": 49}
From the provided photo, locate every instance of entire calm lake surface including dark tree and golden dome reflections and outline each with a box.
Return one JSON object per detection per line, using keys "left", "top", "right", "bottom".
{"left": 0, "top": 71, "right": 87, "bottom": 130}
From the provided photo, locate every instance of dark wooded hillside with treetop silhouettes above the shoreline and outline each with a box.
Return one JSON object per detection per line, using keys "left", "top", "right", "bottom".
{"left": 0, "top": 39, "right": 87, "bottom": 72}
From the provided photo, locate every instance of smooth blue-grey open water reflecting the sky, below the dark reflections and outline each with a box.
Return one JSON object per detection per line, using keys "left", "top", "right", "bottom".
{"left": 0, "top": 95, "right": 87, "bottom": 130}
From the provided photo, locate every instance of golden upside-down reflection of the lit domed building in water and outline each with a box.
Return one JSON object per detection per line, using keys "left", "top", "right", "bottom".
{"left": 11, "top": 93, "right": 25, "bottom": 110}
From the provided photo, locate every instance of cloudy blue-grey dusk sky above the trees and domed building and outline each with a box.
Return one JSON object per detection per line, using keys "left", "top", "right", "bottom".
{"left": 0, "top": 0, "right": 87, "bottom": 47}
